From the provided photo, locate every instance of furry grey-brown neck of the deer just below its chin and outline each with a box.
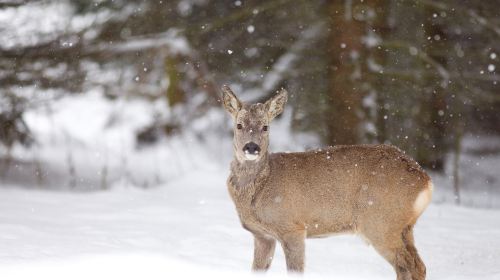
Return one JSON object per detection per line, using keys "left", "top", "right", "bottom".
{"left": 231, "top": 153, "right": 269, "bottom": 190}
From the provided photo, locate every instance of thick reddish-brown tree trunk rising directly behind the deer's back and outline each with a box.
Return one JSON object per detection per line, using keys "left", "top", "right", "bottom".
{"left": 326, "top": 0, "right": 386, "bottom": 145}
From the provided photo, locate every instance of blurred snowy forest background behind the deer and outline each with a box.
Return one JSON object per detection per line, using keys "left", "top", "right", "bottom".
{"left": 0, "top": 0, "right": 500, "bottom": 206}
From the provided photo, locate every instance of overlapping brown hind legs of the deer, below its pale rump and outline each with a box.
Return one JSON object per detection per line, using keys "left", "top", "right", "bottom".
{"left": 367, "top": 225, "right": 426, "bottom": 280}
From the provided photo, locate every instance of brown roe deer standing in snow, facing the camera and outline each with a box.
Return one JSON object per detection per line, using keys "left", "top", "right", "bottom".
{"left": 222, "top": 85, "right": 433, "bottom": 280}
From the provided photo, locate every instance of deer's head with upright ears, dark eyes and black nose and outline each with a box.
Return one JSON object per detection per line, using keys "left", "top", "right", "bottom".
{"left": 222, "top": 86, "right": 287, "bottom": 162}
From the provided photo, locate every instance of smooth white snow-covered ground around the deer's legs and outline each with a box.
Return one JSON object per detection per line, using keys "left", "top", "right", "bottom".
{"left": 0, "top": 167, "right": 500, "bottom": 280}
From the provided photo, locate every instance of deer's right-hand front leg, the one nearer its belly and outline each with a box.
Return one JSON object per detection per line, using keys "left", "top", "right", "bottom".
{"left": 281, "top": 231, "right": 306, "bottom": 273}
